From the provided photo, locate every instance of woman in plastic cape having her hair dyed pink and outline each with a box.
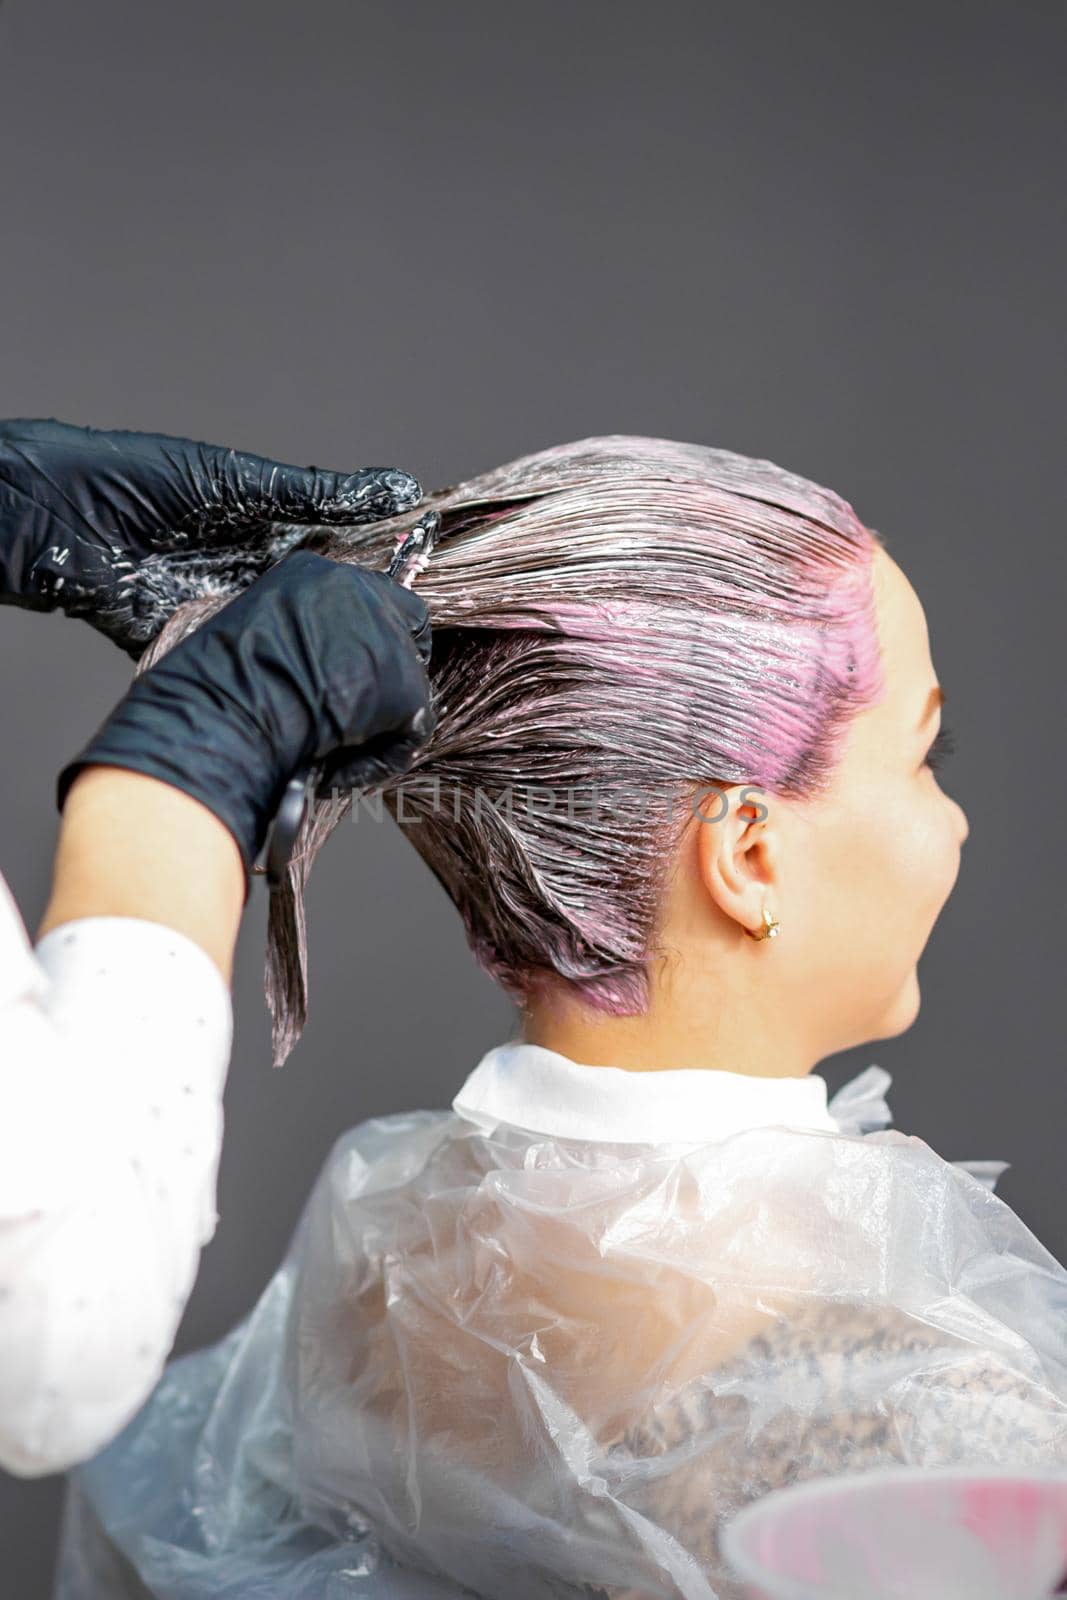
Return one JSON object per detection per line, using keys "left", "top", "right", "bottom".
{"left": 59, "top": 435, "right": 1067, "bottom": 1600}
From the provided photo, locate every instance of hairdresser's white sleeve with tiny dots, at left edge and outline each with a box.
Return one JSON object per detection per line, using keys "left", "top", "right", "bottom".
{"left": 0, "top": 878, "right": 232, "bottom": 1477}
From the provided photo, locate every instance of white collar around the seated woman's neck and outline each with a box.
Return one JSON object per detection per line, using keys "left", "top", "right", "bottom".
{"left": 453, "top": 1038, "right": 844, "bottom": 1146}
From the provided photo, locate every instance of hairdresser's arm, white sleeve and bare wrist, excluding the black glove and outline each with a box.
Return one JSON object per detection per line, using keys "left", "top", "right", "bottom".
{"left": 0, "top": 765, "right": 235, "bottom": 1477}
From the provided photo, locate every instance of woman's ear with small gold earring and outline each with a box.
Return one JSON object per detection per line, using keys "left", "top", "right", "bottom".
{"left": 693, "top": 784, "right": 781, "bottom": 933}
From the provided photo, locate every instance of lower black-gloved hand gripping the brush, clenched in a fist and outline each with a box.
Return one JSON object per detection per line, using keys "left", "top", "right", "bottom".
{"left": 59, "top": 550, "right": 435, "bottom": 874}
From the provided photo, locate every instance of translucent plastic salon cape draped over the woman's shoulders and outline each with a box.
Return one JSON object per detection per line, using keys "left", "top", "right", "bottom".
{"left": 56, "top": 1043, "right": 1067, "bottom": 1600}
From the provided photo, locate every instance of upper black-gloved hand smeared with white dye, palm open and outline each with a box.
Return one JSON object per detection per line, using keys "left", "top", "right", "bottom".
{"left": 0, "top": 418, "right": 422, "bottom": 659}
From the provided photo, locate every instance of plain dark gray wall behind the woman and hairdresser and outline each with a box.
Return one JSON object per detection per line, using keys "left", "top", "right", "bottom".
{"left": 0, "top": 0, "right": 1067, "bottom": 1600}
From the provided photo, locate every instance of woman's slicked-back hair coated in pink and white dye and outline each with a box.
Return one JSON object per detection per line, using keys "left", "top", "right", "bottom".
{"left": 146, "top": 434, "right": 881, "bottom": 1061}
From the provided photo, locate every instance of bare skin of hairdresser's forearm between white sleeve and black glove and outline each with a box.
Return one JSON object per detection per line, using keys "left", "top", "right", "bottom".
{"left": 38, "top": 766, "right": 245, "bottom": 982}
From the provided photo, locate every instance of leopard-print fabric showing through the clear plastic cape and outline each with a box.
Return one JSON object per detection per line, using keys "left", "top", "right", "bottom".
{"left": 584, "top": 1302, "right": 1067, "bottom": 1600}
